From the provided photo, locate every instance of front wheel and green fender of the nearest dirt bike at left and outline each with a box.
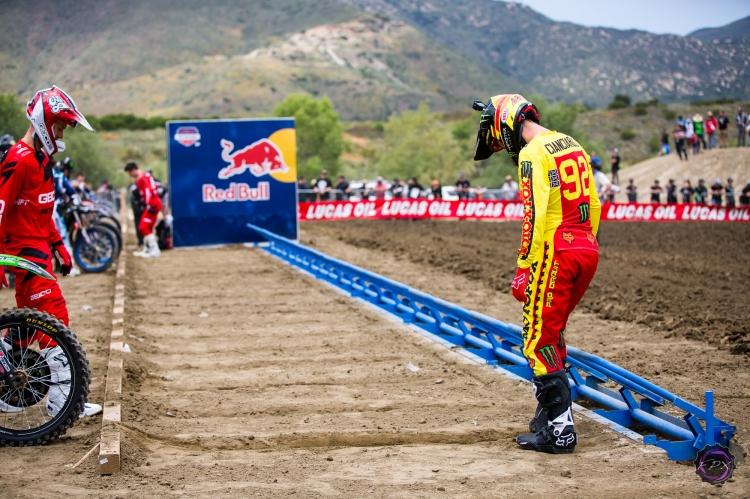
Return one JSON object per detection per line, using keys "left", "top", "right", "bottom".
{"left": 0, "top": 254, "right": 91, "bottom": 446}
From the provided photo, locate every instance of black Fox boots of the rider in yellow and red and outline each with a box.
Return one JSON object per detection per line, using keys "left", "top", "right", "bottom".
{"left": 516, "top": 371, "right": 578, "bottom": 454}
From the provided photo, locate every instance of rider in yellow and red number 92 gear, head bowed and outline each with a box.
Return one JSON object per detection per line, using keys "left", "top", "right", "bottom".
{"left": 474, "top": 94, "right": 601, "bottom": 454}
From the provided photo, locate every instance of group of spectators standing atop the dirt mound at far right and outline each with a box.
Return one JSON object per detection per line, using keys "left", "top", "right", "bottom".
{"left": 661, "top": 107, "right": 750, "bottom": 161}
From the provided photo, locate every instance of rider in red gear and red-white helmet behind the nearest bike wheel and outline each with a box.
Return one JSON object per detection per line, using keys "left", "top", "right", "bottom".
{"left": 0, "top": 86, "right": 101, "bottom": 417}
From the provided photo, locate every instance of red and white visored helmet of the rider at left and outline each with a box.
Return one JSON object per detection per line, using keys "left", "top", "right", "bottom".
{"left": 26, "top": 85, "right": 94, "bottom": 156}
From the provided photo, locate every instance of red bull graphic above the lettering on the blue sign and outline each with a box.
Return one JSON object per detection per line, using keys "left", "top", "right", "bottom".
{"left": 219, "top": 139, "right": 289, "bottom": 179}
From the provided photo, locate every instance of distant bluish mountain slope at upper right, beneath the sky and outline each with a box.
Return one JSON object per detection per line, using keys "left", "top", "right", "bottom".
{"left": 338, "top": 0, "right": 750, "bottom": 107}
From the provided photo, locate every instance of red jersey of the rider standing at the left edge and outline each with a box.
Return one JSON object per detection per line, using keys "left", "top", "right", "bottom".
{"left": 0, "top": 141, "right": 60, "bottom": 244}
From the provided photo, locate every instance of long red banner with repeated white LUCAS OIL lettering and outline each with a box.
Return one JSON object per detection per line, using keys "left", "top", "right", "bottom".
{"left": 299, "top": 199, "right": 750, "bottom": 222}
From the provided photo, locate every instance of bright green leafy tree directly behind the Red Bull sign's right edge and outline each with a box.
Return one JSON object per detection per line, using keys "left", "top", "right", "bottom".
{"left": 273, "top": 94, "right": 344, "bottom": 179}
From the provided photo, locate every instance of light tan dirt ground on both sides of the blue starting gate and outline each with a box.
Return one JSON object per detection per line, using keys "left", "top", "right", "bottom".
{"left": 0, "top": 224, "right": 750, "bottom": 499}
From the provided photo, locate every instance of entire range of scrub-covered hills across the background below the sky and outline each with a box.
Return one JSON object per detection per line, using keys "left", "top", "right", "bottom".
{"left": 0, "top": 0, "right": 750, "bottom": 118}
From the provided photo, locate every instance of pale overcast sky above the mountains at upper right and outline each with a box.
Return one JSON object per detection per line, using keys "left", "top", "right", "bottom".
{"left": 519, "top": 0, "right": 750, "bottom": 35}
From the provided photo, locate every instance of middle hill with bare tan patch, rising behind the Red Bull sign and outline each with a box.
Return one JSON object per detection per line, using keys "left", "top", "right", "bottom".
{"left": 75, "top": 15, "right": 523, "bottom": 120}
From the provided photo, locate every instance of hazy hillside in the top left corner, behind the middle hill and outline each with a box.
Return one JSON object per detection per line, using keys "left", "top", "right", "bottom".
{"left": 0, "top": 0, "right": 360, "bottom": 98}
